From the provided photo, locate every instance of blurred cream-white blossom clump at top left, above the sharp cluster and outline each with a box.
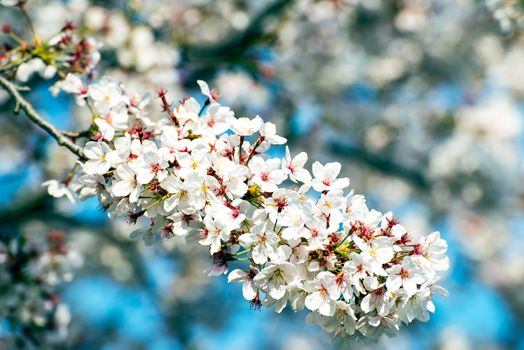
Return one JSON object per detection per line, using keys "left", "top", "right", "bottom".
{"left": 28, "top": 0, "right": 180, "bottom": 92}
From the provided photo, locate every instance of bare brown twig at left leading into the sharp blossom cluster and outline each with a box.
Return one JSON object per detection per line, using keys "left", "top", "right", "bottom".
{"left": 0, "top": 76, "right": 85, "bottom": 159}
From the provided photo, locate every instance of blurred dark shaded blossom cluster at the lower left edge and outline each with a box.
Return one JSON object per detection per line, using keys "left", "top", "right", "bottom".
{"left": 0, "top": 231, "right": 81, "bottom": 344}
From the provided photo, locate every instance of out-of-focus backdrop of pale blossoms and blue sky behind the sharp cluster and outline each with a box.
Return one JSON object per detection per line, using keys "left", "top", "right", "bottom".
{"left": 0, "top": 0, "right": 524, "bottom": 350}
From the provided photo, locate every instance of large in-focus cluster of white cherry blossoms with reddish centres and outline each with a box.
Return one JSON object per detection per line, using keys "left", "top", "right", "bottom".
{"left": 46, "top": 75, "right": 449, "bottom": 337}
